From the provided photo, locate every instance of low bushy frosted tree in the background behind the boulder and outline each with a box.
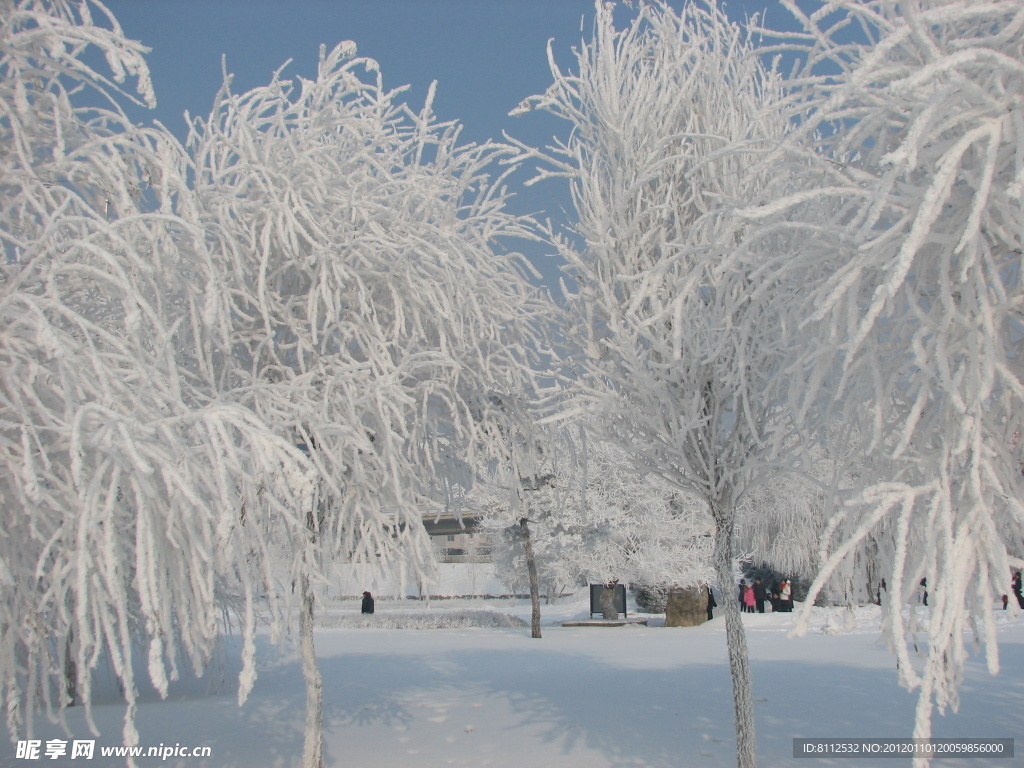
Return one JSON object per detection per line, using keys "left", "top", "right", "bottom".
{"left": 477, "top": 425, "right": 713, "bottom": 596}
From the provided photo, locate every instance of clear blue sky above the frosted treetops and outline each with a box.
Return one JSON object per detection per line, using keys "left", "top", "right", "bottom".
{"left": 99, "top": 0, "right": 787, "bottom": 281}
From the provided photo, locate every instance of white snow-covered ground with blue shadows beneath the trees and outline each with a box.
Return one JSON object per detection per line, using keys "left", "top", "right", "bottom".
{"left": 0, "top": 593, "right": 1024, "bottom": 768}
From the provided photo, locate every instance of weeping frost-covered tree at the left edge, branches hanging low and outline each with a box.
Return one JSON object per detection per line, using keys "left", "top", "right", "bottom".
{"left": 0, "top": 0, "right": 309, "bottom": 743}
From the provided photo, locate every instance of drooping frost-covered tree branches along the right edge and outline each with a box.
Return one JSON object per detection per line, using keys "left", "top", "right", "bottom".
{"left": 751, "top": 0, "right": 1024, "bottom": 757}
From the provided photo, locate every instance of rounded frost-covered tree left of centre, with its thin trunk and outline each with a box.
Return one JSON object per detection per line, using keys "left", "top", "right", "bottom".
{"left": 187, "top": 42, "right": 548, "bottom": 766}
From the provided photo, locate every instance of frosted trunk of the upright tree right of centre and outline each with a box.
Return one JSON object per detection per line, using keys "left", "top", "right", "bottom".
{"left": 711, "top": 504, "right": 757, "bottom": 768}
